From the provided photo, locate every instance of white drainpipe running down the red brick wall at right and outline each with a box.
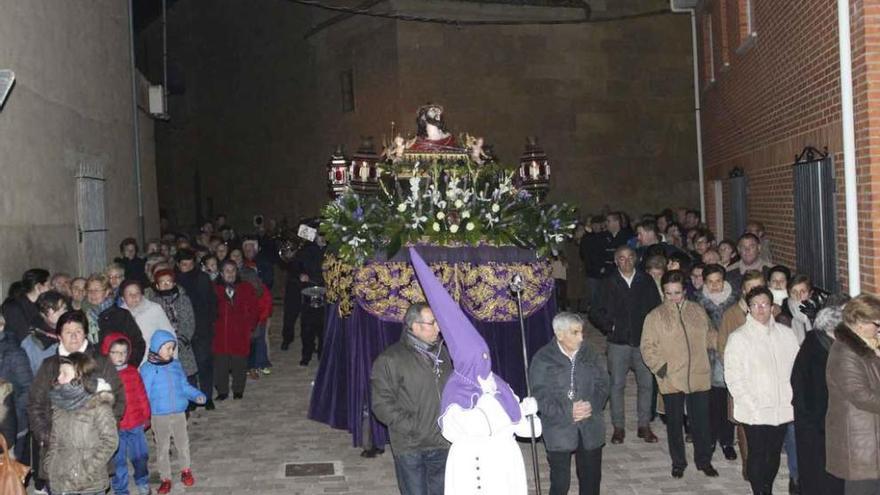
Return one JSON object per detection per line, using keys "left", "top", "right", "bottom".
{"left": 837, "top": 0, "right": 862, "bottom": 296}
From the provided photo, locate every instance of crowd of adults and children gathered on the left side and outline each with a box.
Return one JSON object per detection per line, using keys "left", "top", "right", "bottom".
{"left": 0, "top": 215, "right": 323, "bottom": 495}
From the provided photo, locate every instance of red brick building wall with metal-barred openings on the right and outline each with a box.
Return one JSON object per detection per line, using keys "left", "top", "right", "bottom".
{"left": 699, "top": 0, "right": 880, "bottom": 292}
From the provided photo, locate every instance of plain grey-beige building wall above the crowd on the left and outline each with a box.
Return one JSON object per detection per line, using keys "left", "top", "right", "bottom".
{"left": 0, "top": 0, "right": 158, "bottom": 293}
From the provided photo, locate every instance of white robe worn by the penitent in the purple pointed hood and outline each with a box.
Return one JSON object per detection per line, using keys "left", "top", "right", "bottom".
{"left": 440, "top": 394, "right": 541, "bottom": 495}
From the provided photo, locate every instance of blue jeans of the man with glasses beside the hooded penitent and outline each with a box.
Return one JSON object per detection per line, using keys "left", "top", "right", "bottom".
{"left": 394, "top": 449, "right": 449, "bottom": 495}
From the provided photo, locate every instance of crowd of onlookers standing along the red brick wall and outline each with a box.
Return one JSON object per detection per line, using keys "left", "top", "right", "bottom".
{"left": 538, "top": 208, "right": 880, "bottom": 495}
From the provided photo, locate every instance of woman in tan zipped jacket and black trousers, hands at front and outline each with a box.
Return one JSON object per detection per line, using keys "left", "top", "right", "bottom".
{"left": 641, "top": 270, "right": 718, "bottom": 478}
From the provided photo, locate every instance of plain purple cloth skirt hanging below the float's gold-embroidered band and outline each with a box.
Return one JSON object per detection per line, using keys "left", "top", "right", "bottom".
{"left": 309, "top": 297, "right": 556, "bottom": 447}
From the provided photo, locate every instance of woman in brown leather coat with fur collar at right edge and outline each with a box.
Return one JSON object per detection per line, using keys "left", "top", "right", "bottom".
{"left": 825, "top": 294, "right": 880, "bottom": 495}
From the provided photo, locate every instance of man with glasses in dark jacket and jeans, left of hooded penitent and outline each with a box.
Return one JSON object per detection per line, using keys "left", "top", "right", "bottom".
{"left": 370, "top": 303, "right": 452, "bottom": 495}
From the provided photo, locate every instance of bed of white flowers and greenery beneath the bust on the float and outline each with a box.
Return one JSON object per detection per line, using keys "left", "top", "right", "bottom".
{"left": 321, "top": 154, "right": 577, "bottom": 265}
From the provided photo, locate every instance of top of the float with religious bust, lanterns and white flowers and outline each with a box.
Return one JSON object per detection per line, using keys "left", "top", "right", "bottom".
{"left": 320, "top": 104, "right": 577, "bottom": 266}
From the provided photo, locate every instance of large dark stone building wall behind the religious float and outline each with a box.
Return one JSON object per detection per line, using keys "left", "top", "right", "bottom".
{"left": 148, "top": 0, "right": 699, "bottom": 232}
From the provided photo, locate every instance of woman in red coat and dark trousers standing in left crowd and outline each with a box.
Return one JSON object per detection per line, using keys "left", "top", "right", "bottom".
{"left": 213, "top": 260, "right": 260, "bottom": 400}
